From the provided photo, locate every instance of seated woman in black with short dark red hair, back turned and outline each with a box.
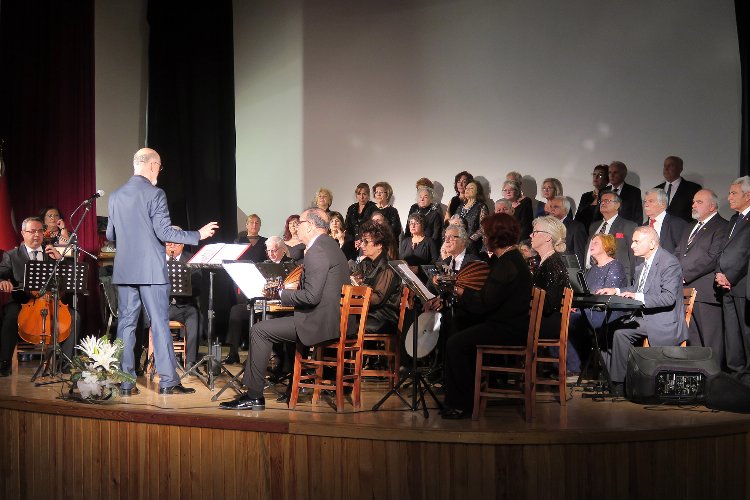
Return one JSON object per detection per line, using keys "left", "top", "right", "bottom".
{"left": 442, "top": 214, "right": 532, "bottom": 419}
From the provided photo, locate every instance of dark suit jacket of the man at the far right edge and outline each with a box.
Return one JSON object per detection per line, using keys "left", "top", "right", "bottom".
{"left": 716, "top": 213, "right": 750, "bottom": 297}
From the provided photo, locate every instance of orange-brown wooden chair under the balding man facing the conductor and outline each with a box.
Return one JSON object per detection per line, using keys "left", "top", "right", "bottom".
{"left": 289, "top": 285, "right": 372, "bottom": 413}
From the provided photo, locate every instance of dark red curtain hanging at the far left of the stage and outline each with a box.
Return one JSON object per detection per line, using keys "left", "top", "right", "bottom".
{"left": 0, "top": 0, "right": 100, "bottom": 333}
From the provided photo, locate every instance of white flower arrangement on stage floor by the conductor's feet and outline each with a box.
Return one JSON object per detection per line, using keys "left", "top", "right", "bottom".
{"left": 70, "top": 335, "right": 135, "bottom": 400}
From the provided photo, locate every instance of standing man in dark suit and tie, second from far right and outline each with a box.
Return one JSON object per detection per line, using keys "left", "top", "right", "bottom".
{"left": 675, "top": 189, "right": 727, "bottom": 365}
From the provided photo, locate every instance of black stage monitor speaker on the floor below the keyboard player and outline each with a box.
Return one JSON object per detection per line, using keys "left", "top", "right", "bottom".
{"left": 625, "top": 347, "right": 721, "bottom": 404}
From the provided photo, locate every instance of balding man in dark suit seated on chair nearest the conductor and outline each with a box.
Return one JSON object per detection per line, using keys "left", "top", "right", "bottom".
{"left": 219, "top": 208, "right": 349, "bottom": 410}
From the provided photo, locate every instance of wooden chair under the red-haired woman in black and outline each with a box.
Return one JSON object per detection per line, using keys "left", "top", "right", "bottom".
{"left": 472, "top": 287, "right": 546, "bottom": 421}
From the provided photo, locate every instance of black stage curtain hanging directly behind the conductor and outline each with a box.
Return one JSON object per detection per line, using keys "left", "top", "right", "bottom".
{"left": 147, "top": 0, "right": 237, "bottom": 338}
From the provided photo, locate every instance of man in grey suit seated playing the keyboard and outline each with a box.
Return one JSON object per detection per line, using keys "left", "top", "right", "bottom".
{"left": 595, "top": 226, "right": 688, "bottom": 396}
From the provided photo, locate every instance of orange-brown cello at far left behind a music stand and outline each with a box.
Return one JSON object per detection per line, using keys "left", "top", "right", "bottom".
{"left": 18, "top": 292, "right": 72, "bottom": 344}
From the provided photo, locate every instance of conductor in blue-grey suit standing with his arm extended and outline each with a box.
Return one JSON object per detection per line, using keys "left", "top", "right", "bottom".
{"left": 107, "top": 148, "right": 219, "bottom": 396}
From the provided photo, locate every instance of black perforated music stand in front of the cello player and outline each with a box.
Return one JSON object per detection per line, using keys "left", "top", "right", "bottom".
{"left": 24, "top": 260, "right": 88, "bottom": 386}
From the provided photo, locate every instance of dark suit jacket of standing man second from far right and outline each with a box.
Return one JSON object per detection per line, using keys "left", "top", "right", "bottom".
{"left": 675, "top": 214, "right": 727, "bottom": 304}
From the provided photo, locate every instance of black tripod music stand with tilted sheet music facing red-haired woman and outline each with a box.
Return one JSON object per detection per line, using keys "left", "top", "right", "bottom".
{"left": 372, "top": 260, "right": 443, "bottom": 418}
